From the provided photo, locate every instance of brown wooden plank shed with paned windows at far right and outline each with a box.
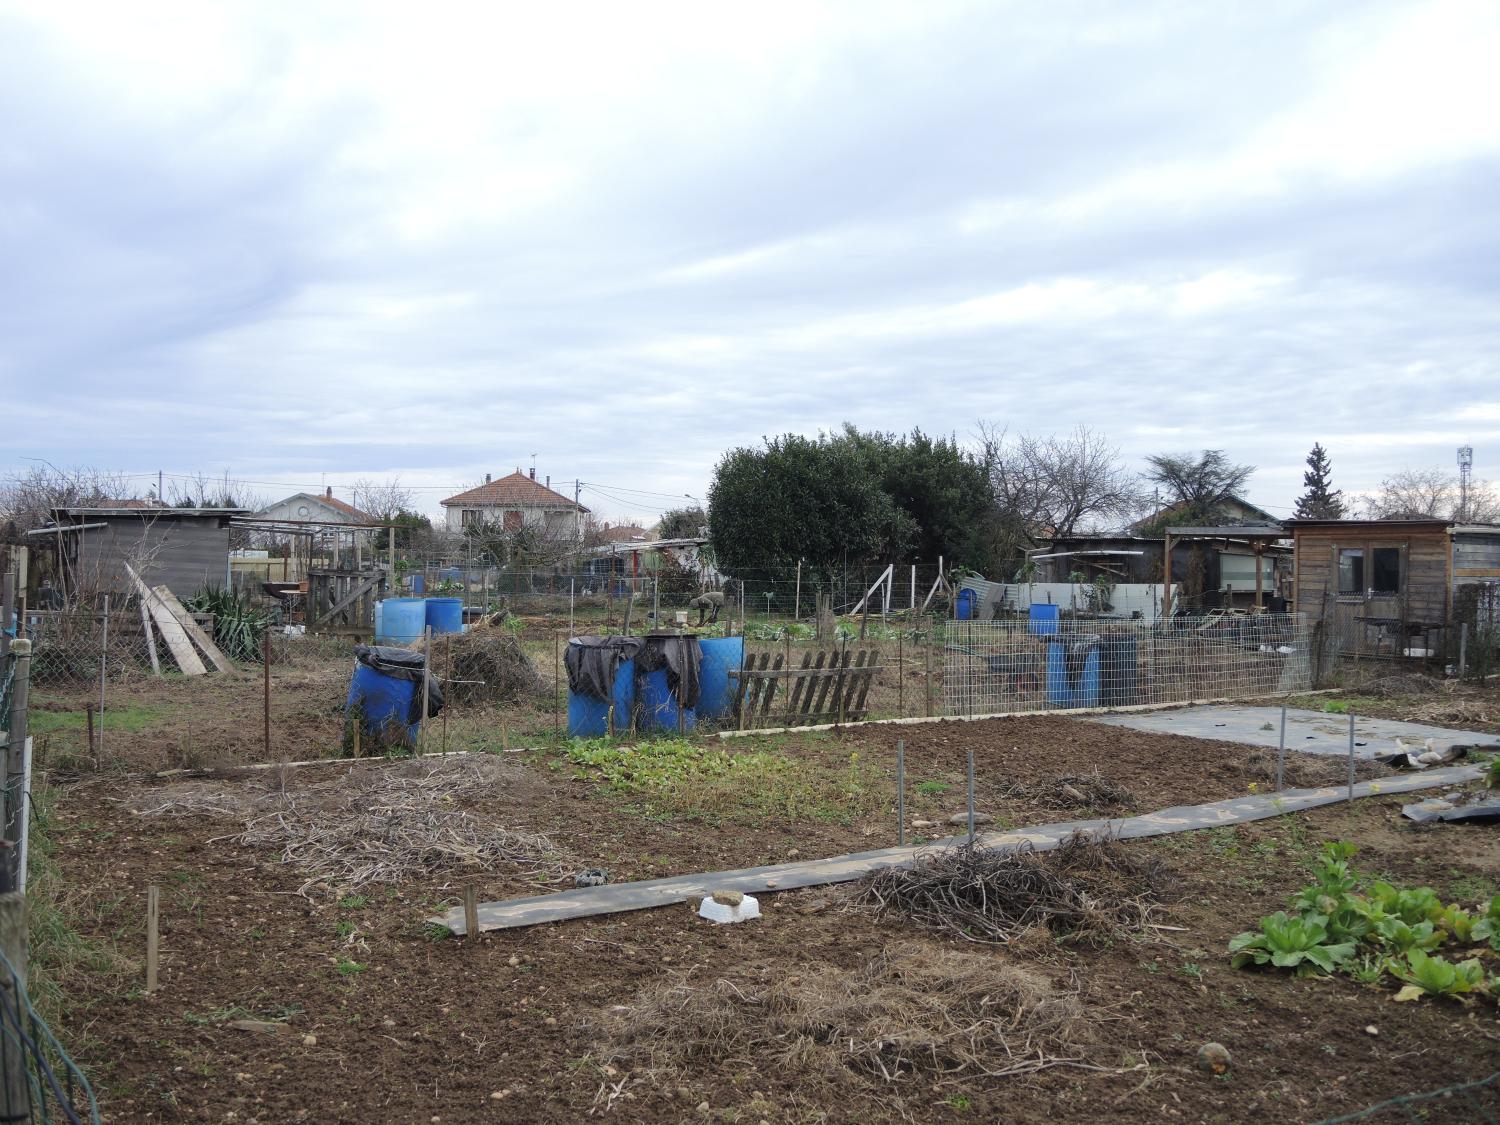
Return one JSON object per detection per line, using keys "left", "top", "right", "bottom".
{"left": 1287, "top": 519, "right": 1500, "bottom": 657}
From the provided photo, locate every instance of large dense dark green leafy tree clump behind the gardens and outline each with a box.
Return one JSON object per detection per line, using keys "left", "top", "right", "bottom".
{"left": 708, "top": 426, "right": 993, "bottom": 573}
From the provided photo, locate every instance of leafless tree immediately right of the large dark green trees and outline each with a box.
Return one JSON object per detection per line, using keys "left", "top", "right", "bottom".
{"left": 980, "top": 423, "right": 1142, "bottom": 540}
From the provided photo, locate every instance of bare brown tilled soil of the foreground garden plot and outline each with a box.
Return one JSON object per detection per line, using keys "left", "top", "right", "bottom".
{"left": 41, "top": 719, "right": 1500, "bottom": 1122}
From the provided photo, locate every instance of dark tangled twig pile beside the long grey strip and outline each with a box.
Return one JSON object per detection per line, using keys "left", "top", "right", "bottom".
{"left": 854, "top": 834, "right": 1169, "bottom": 942}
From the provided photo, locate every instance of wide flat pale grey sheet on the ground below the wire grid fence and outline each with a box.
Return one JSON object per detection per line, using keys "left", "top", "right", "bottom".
{"left": 1088, "top": 705, "right": 1500, "bottom": 758}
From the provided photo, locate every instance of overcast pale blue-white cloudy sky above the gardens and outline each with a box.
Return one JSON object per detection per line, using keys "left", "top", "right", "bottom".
{"left": 0, "top": 0, "right": 1500, "bottom": 528}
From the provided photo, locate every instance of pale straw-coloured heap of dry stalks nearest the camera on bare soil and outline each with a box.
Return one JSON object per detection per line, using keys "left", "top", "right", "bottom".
{"left": 600, "top": 944, "right": 1089, "bottom": 1082}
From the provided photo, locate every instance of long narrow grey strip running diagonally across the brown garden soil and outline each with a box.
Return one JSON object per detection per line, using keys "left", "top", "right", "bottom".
{"left": 428, "top": 765, "right": 1481, "bottom": 935}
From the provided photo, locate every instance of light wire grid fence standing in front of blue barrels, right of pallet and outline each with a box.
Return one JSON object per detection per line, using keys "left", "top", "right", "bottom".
{"left": 942, "top": 614, "right": 1313, "bottom": 716}
